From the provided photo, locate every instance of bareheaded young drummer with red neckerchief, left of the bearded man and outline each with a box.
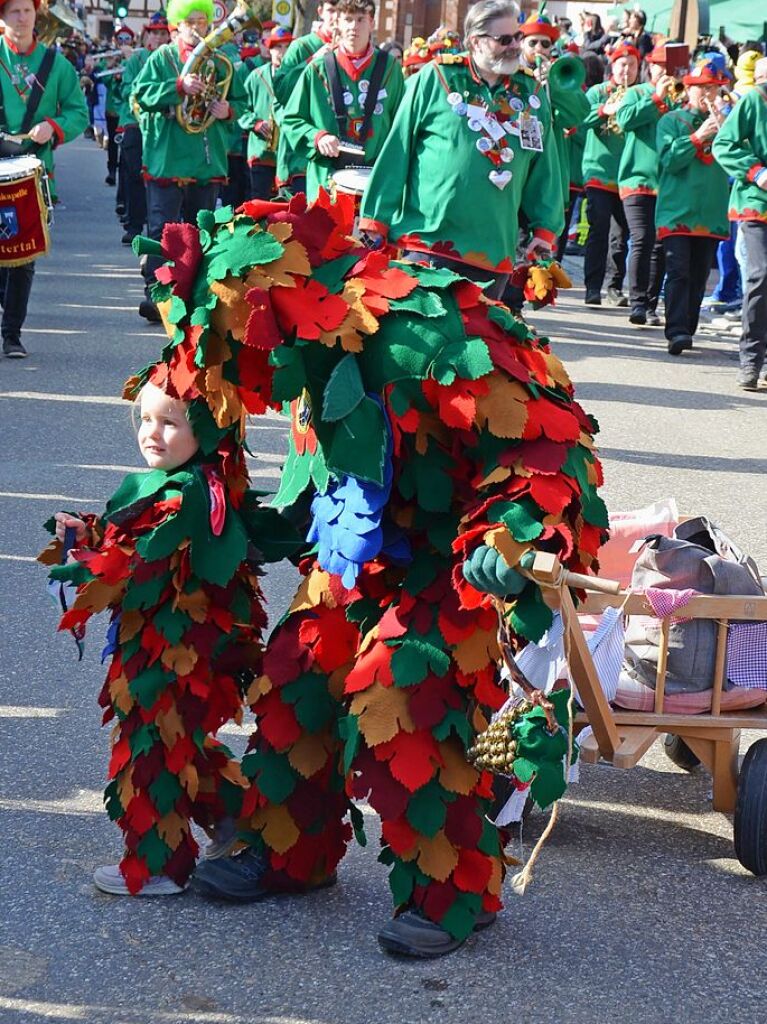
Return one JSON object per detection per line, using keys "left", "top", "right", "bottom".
{"left": 283, "top": 0, "right": 404, "bottom": 199}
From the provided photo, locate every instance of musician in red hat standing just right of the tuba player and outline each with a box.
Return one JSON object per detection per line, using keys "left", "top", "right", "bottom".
{"left": 240, "top": 25, "right": 301, "bottom": 200}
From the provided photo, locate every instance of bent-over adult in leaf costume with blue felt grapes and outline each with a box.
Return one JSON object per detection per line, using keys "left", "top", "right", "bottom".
{"left": 134, "top": 191, "right": 607, "bottom": 956}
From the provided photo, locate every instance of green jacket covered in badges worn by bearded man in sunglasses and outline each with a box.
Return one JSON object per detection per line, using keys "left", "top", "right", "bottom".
{"left": 359, "top": 57, "right": 564, "bottom": 272}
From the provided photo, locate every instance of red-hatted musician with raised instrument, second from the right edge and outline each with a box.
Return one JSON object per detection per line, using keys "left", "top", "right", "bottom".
{"left": 655, "top": 60, "right": 729, "bottom": 355}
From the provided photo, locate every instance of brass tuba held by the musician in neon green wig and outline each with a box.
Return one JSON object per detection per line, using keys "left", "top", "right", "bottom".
{"left": 176, "top": 0, "right": 261, "bottom": 135}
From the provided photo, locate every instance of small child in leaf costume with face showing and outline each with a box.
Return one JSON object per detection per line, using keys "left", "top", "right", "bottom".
{"left": 40, "top": 337, "right": 299, "bottom": 896}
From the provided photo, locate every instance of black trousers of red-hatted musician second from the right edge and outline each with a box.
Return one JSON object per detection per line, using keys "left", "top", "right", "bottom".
{"left": 664, "top": 234, "right": 719, "bottom": 341}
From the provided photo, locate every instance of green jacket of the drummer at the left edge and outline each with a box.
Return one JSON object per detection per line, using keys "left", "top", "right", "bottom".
{"left": 0, "top": 37, "right": 88, "bottom": 195}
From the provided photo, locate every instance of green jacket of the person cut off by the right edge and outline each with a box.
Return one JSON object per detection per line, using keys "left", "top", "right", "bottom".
{"left": 713, "top": 85, "right": 767, "bottom": 221}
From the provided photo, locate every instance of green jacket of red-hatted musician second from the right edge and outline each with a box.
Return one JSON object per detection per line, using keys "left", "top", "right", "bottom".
{"left": 655, "top": 110, "right": 730, "bottom": 239}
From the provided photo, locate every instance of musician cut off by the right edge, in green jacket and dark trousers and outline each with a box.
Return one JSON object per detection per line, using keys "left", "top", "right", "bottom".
{"left": 713, "top": 57, "right": 767, "bottom": 391}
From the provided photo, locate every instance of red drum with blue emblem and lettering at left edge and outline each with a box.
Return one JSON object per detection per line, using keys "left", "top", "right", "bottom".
{"left": 0, "top": 156, "right": 51, "bottom": 267}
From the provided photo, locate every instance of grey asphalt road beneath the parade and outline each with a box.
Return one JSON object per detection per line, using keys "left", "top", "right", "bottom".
{"left": 0, "top": 141, "right": 767, "bottom": 1024}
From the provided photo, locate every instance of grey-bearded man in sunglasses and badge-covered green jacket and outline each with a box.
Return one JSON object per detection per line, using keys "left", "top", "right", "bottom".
{"left": 359, "top": 0, "right": 564, "bottom": 297}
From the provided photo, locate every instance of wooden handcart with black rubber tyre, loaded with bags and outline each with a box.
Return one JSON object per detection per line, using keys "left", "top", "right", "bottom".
{"left": 532, "top": 554, "right": 767, "bottom": 874}
